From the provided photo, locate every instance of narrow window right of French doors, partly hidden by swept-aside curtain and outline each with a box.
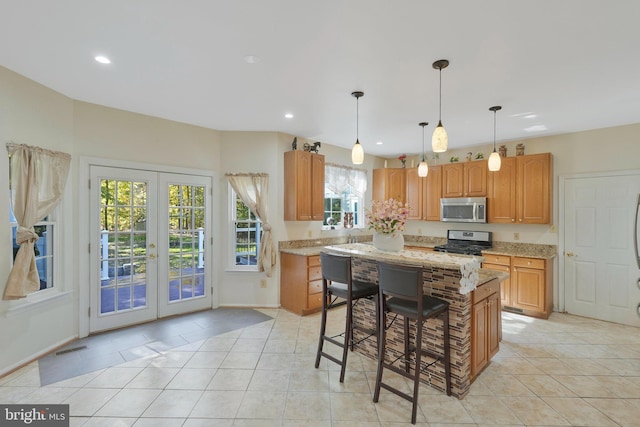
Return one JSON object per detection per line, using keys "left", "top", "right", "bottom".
{"left": 229, "top": 185, "right": 262, "bottom": 271}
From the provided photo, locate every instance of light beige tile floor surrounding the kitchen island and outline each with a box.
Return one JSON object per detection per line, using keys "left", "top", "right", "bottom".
{"left": 0, "top": 309, "right": 640, "bottom": 427}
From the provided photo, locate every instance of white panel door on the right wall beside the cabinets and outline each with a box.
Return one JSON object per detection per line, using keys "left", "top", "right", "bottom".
{"left": 561, "top": 174, "right": 640, "bottom": 326}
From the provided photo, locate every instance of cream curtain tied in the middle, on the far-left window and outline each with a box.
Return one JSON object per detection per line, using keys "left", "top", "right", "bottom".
{"left": 2, "top": 143, "right": 71, "bottom": 300}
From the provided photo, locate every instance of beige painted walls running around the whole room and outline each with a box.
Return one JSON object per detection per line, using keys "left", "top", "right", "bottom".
{"left": 0, "top": 67, "right": 640, "bottom": 374}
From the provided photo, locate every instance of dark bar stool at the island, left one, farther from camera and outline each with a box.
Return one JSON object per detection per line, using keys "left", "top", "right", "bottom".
{"left": 316, "top": 252, "right": 378, "bottom": 382}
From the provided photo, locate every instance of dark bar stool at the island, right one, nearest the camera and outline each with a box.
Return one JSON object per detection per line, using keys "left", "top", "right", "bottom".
{"left": 373, "top": 261, "right": 451, "bottom": 424}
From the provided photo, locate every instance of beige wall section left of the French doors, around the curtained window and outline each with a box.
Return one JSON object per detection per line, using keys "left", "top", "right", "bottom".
{"left": 0, "top": 67, "right": 78, "bottom": 374}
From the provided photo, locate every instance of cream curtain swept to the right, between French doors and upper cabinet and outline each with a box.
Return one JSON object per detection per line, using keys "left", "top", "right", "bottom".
{"left": 226, "top": 173, "right": 276, "bottom": 277}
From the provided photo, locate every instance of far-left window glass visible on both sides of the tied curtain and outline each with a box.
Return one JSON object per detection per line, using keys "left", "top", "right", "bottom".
{"left": 9, "top": 210, "right": 55, "bottom": 290}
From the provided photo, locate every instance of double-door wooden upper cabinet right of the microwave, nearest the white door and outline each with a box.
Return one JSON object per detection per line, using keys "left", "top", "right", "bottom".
{"left": 487, "top": 153, "right": 553, "bottom": 224}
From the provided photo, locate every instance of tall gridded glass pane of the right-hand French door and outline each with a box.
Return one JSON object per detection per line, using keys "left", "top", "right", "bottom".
{"left": 168, "top": 184, "right": 205, "bottom": 302}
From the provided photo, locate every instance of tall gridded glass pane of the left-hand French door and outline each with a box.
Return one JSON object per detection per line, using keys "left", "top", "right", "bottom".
{"left": 99, "top": 179, "right": 148, "bottom": 314}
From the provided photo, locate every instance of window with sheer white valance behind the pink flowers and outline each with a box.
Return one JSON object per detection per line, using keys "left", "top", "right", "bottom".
{"left": 323, "top": 164, "right": 367, "bottom": 230}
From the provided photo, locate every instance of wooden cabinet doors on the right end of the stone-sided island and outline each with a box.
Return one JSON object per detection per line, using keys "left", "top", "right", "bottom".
{"left": 471, "top": 279, "right": 501, "bottom": 381}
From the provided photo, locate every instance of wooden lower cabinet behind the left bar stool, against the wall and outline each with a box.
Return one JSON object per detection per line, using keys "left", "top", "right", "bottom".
{"left": 280, "top": 252, "right": 322, "bottom": 316}
